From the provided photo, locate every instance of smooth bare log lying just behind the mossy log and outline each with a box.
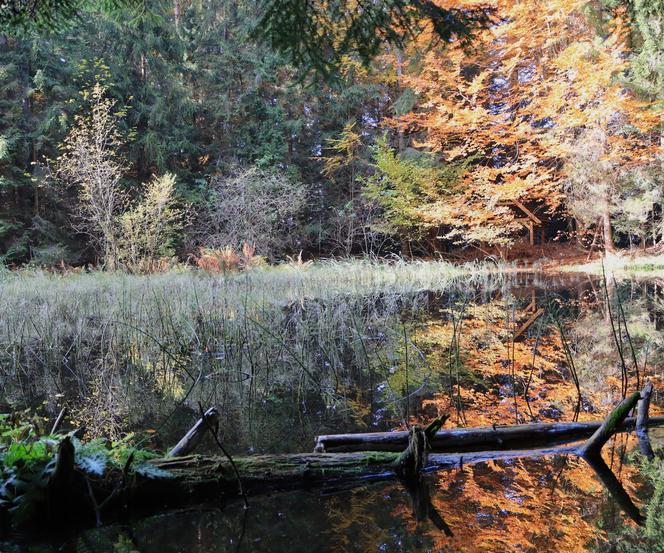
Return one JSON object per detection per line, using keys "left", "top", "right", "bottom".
{"left": 314, "top": 417, "right": 664, "bottom": 453}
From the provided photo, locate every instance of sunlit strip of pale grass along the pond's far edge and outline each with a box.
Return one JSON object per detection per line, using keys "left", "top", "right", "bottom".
{"left": 0, "top": 259, "right": 501, "bottom": 299}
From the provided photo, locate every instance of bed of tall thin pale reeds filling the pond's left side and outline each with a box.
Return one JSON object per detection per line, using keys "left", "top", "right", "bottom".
{"left": 0, "top": 260, "right": 501, "bottom": 450}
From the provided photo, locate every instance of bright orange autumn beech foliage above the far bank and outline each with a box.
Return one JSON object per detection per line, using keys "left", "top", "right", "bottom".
{"left": 389, "top": 0, "right": 662, "bottom": 242}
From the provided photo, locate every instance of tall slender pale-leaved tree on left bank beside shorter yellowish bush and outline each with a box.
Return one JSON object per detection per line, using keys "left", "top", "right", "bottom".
{"left": 56, "top": 82, "right": 126, "bottom": 269}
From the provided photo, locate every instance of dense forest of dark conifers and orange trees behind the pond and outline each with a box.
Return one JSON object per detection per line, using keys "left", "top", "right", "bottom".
{"left": 0, "top": 0, "right": 664, "bottom": 270}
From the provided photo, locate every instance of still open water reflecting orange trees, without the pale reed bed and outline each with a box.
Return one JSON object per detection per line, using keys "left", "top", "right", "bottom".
{"left": 5, "top": 274, "right": 664, "bottom": 553}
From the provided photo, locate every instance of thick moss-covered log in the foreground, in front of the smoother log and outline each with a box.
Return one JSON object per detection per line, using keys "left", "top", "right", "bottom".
{"left": 91, "top": 447, "right": 574, "bottom": 514}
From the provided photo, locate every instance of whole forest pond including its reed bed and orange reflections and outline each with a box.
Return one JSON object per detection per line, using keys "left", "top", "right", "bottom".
{"left": 0, "top": 266, "right": 664, "bottom": 553}
